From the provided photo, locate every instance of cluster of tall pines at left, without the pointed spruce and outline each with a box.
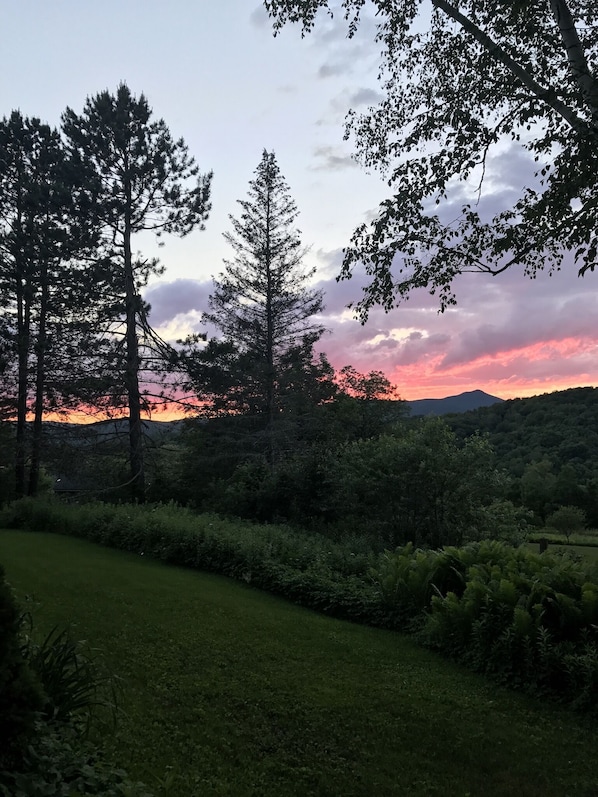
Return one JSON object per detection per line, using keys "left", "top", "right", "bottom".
{"left": 0, "top": 84, "right": 212, "bottom": 497}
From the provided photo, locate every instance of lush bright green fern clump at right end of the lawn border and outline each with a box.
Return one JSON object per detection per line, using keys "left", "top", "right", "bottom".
{"left": 372, "top": 541, "right": 598, "bottom": 711}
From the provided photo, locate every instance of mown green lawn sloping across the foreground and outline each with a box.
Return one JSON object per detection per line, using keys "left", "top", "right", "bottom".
{"left": 0, "top": 531, "right": 598, "bottom": 797}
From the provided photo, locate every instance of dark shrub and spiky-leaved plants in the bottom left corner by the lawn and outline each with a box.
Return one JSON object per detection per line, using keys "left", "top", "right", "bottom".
{"left": 0, "top": 568, "right": 149, "bottom": 797}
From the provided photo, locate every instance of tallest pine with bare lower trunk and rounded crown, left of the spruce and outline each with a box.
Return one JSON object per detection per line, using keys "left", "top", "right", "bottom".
{"left": 63, "top": 83, "right": 212, "bottom": 500}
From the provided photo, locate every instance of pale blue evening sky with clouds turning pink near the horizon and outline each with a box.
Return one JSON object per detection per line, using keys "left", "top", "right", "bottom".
{"left": 0, "top": 0, "right": 598, "bottom": 400}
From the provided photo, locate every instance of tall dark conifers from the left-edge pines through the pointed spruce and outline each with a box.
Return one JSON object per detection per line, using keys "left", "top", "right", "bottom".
{"left": 0, "top": 84, "right": 408, "bottom": 501}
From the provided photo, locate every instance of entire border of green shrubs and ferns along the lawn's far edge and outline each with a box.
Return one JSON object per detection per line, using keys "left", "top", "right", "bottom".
{"left": 0, "top": 500, "right": 598, "bottom": 712}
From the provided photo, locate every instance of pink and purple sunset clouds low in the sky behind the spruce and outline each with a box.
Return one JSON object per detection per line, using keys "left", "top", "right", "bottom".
{"left": 146, "top": 236, "right": 598, "bottom": 399}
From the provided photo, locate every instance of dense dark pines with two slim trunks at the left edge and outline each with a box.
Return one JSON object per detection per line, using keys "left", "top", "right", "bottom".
{"left": 0, "top": 111, "right": 97, "bottom": 495}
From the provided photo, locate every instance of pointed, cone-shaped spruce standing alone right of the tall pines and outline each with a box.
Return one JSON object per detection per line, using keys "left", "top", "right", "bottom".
{"left": 183, "top": 150, "right": 332, "bottom": 466}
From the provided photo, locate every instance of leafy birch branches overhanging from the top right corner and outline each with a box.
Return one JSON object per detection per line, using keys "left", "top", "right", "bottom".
{"left": 264, "top": 0, "right": 598, "bottom": 321}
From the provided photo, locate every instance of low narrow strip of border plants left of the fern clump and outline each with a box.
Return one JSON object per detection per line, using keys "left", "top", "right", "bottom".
{"left": 0, "top": 499, "right": 386, "bottom": 625}
